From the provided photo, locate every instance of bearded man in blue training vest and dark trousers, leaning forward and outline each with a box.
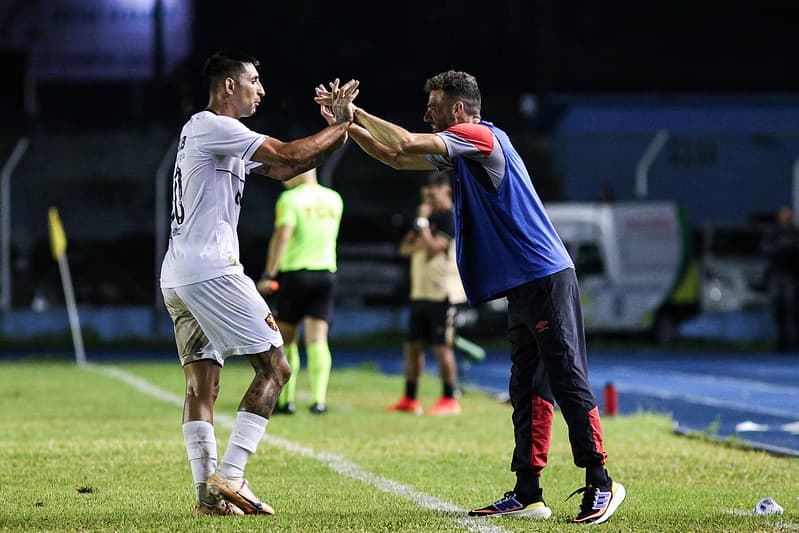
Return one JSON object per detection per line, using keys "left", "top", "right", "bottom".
{"left": 316, "top": 70, "right": 625, "bottom": 524}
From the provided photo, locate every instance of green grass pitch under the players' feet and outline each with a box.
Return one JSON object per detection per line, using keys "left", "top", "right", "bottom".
{"left": 0, "top": 361, "right": 799, "bottom": 533}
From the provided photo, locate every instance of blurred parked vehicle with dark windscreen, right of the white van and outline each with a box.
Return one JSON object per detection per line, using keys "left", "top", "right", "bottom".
{"left": 699, "top": 224, "right": 769, "bottom": 313}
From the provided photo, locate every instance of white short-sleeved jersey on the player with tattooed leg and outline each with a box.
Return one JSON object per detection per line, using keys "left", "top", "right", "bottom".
{"left": 161, "top": 110, "right": 265, "bottom": 288}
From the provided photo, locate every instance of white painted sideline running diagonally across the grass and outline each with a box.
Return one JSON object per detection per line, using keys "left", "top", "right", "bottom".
{"left": 87, "top": 363, "right": 509, "bottom": 533}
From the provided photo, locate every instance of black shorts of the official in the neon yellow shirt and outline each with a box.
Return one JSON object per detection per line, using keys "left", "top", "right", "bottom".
{"left": 269, "top": 270, "right": 336, "bottom": 324}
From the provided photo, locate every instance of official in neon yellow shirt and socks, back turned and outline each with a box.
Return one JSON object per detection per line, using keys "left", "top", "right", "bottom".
{"left": 257, "top": 169, "right": 343, "bottom": 415}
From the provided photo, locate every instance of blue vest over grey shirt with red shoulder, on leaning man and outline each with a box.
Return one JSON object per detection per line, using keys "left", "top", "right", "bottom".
{"left": 427, "top": 121, "right": 574, "bottom": 305}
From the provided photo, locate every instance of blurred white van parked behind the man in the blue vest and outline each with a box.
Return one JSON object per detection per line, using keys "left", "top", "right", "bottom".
{"left": 545, "top": 201, "right": 698, "bottom": 342}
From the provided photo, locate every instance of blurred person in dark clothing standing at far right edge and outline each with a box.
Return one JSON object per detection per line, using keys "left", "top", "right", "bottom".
{"left": 763, "top": 205, "right": 799, "bottom": 352}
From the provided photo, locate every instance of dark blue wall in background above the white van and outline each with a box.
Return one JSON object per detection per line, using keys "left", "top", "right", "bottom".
{"left": 553, "top": 97, "right": 799, "bottom": 224}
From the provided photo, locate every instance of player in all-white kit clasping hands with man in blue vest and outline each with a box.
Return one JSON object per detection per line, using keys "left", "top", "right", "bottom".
{"left": 161, "top": 52, "right": 358, "bottom": 515}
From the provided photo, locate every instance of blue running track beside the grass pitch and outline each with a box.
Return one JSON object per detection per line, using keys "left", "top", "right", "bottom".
{"left": 372, "top": 350, "right": 799, "bottom": 457}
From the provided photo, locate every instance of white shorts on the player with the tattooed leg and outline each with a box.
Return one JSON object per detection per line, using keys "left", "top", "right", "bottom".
{"left": 161, "top": 273, "right": 283, "bottom": 365}
